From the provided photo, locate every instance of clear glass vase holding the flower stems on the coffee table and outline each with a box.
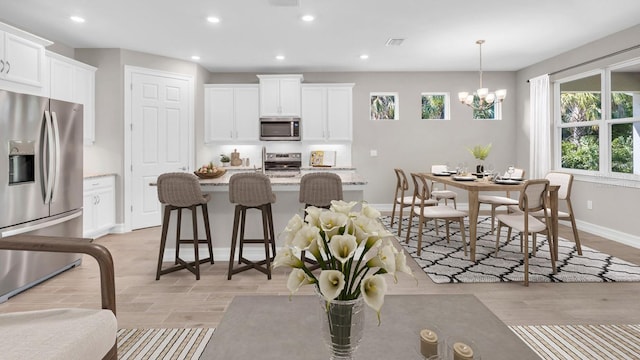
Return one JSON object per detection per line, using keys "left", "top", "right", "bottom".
{"left": 318, "top": 296, "right": 364, "bottom": 360}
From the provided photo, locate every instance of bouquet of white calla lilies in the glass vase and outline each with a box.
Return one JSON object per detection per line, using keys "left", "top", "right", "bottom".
{"left": 272, "top": 201, "right": 413, "bottom": 323}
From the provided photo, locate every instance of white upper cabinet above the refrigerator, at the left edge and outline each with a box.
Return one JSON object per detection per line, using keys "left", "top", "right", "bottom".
{"left": 0, "top": 23, "right": 52, "bottom": 95}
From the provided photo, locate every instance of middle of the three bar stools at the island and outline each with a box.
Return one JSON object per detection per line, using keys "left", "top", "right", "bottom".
{"left": 227, "top": 173, "right": 276, "bottom": 280}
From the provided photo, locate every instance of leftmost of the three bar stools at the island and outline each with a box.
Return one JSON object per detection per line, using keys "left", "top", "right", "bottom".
{"left": 156, "top": 173, "right": 213, "bottom": 280}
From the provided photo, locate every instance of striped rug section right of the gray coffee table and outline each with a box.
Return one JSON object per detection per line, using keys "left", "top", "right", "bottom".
{"left": 509, "top": 325, "right": 640, "bottom": 360}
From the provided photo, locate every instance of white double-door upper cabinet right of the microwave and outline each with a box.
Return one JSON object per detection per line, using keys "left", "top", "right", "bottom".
{"left": 301, "top": 84, "right": 354, "bottom": 141}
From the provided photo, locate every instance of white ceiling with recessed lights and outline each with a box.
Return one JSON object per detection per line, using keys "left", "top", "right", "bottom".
{"left": 0, "top": 0, "right": 640, "bottom": 72}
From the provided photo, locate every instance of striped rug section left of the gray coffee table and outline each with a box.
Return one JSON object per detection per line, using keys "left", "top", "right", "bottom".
{"left": 118, "top": 328, "right": 214, "bottom": 360}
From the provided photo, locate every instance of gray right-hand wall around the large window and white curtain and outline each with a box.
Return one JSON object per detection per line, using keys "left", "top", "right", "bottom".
{"left": 515, "top": 25, "right": 640, "bottom": 236}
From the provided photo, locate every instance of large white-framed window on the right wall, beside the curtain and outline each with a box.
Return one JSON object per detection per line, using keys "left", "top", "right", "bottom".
{"left": 554, "top": 59, "right": 640, "bottom": 180}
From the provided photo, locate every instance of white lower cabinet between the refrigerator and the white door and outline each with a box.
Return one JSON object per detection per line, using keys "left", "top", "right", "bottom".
{"left": 82, "top": 175, "right": 116, "bottom": 239}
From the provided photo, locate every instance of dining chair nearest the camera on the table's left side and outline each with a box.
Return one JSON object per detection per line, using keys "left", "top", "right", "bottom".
{"left": 405, "top": 173, "right": 468, "bottom": 256}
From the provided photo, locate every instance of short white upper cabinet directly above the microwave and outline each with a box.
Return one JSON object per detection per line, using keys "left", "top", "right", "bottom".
{"left": 258, "top": 75, "right": 302, "bottom": 117}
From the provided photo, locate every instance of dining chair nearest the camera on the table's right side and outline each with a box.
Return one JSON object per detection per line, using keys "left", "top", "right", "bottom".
{"left": 495, "top": 179, "right": 556, "bottom": 286}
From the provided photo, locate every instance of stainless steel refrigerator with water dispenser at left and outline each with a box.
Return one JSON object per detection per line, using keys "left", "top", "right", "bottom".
{"left": 0, "top": 90, "right": 83, "bottom": 303}
